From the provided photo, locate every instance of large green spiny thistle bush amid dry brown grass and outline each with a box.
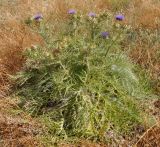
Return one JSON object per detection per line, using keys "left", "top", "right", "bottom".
{"left": 16, "top": 13, "right": 154, "bottom": 142}
